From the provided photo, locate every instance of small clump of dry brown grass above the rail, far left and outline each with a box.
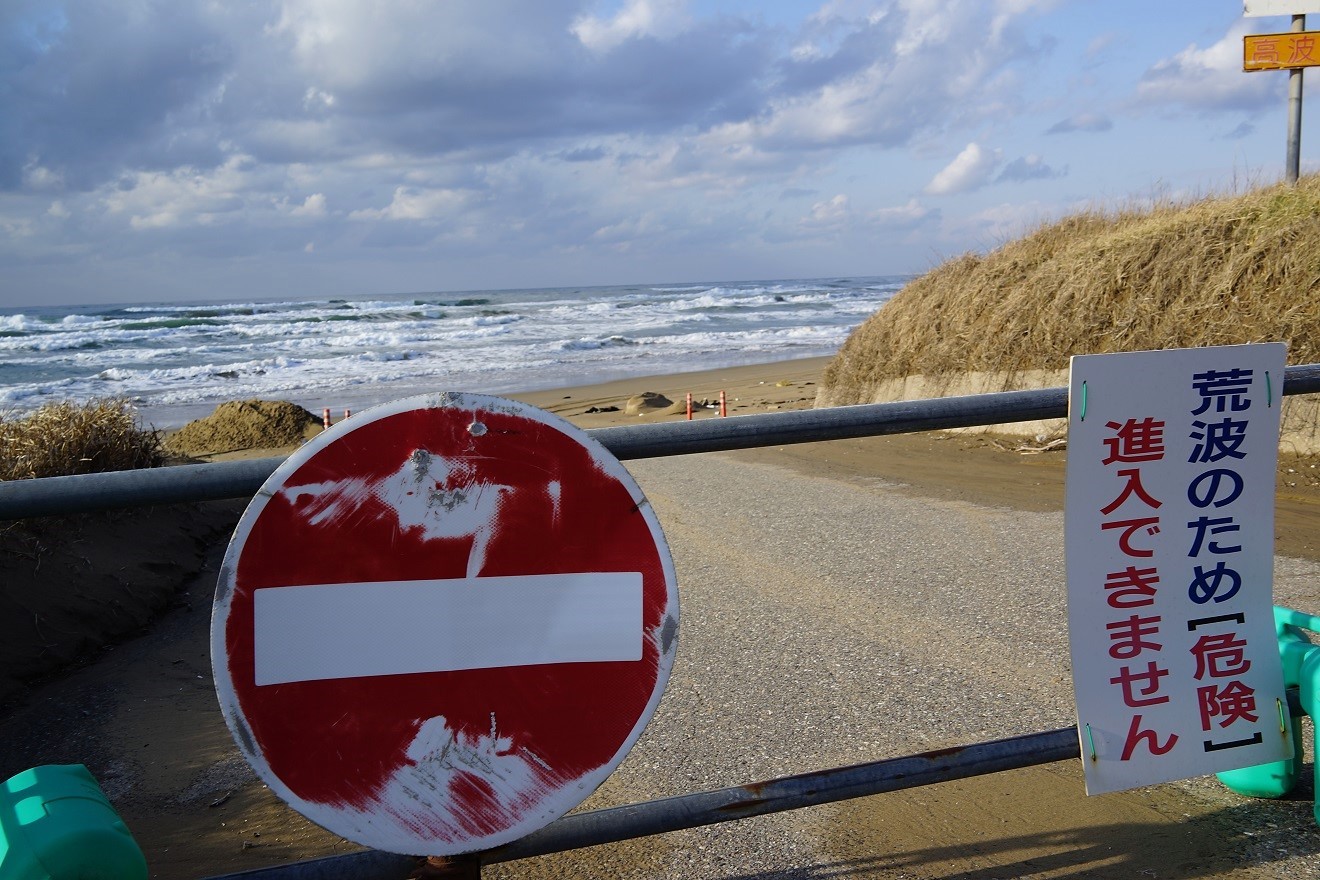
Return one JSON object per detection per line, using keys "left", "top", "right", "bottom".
{"left": 0, "top": 400, "right": 164, "bottom": 480}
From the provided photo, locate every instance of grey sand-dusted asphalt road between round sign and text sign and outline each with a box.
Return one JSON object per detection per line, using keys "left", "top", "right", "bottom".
{"left": 483, "top": 454, "right": 1320, "bottom": 879}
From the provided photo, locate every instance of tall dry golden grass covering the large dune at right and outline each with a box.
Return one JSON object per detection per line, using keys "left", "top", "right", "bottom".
{"left": 822, "top": 175, "right": 1320, "bottom": 405}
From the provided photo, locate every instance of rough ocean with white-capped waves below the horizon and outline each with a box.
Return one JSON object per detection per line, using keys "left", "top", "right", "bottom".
{"left": 0, "top": 276, "right": 908, "bottom": 429}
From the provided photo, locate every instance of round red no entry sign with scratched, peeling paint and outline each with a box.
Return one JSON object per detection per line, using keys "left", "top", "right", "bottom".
{"left": 211, "top": 394, "right": 678, "bottom": 855}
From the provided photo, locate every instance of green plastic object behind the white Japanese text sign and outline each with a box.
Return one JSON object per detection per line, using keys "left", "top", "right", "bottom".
{"left": 1216, "top": 606, "right": 1320, "bottom": 823}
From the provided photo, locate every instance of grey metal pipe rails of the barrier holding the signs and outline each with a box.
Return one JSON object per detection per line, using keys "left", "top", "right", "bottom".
{"left": 0, "top": 364, "right": 1320, "bottom": 880}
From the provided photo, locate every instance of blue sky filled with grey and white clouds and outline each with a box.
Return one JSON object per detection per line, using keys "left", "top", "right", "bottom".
{"left": 0, "top": 0, "right": 1320, "bottom": 307}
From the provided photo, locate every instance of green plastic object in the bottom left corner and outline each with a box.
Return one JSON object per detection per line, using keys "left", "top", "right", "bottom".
{"left": 0, "top": 764, "right": 147, "bottom": 880}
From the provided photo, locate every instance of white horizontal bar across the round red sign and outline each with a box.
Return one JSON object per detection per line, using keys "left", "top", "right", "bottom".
{"left": 252, "top": 571, "right": 642, "bottom": 685}
